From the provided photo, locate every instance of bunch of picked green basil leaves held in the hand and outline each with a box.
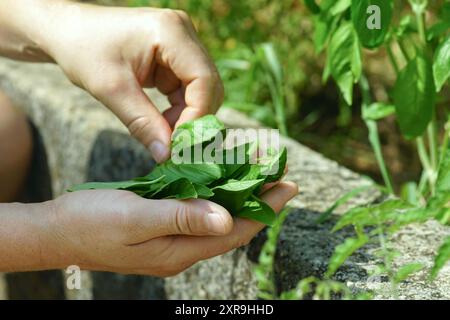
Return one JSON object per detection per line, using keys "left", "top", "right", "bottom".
{"left": 69, "top": 115, "right": 287, "bottom": 225}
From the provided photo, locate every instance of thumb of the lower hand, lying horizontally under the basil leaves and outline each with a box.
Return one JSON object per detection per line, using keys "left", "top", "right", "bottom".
{"left": 127, "top": 197, "right": 233, "bottom": 244}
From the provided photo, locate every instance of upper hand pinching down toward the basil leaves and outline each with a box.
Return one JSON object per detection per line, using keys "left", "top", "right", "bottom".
{"left": 42, "top": 2, "right": 223, "bottom": 162}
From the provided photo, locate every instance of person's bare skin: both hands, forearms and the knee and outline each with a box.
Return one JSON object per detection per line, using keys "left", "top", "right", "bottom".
{"left": 0, "top": 0, "right": 297, "bottom": 276}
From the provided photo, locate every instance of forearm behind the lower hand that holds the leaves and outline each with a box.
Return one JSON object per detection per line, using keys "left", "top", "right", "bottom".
{"left": 0, "top": 202, "right": 63, "bottom": 272}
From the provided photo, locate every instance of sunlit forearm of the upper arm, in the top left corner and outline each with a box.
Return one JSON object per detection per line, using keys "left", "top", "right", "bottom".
{"left": 0, "top": 0, "right": 72, "bottom": 62}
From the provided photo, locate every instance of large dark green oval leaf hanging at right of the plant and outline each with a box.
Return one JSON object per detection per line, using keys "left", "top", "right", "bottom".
{"left": 393, "top": 55, "right": 435, "bottom": 138}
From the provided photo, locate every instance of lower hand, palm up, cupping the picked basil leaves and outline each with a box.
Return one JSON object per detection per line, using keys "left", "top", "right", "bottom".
{"left": 44, "top": 182, "right": 297, "bottom": 276}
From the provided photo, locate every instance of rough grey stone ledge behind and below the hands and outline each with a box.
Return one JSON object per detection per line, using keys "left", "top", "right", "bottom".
{"left": 0, "top": 59, "right": 450, "bottom": 299}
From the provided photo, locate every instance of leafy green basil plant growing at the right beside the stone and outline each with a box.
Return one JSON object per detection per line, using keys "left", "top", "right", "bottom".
{"left": 256, "top": 0, "right": 450, "bottom": 298}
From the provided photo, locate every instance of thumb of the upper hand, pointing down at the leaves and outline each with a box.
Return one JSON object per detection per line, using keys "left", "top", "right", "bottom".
{"left": 95, "top": 77, "right": 172, "bottom": 163}
